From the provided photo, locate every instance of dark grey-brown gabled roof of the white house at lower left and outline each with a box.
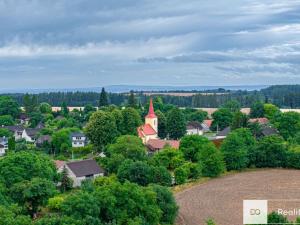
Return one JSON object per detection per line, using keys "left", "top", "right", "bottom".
{"left": 66, "top": 159, "right": 104, "bottom": 177}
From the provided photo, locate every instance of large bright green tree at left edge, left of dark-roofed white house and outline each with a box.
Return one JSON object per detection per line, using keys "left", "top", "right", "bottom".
{"left": 0, "top": 151, "right": 57, "bottom": 187}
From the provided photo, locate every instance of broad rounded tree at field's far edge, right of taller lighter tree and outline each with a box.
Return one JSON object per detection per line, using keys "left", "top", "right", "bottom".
{"left": 250, "top": 135, "right": 287, "bottom": 167}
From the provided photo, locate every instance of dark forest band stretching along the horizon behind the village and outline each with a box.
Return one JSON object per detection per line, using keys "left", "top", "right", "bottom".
{"left": 3, "top": 85, "right": 300, "bottom": 108}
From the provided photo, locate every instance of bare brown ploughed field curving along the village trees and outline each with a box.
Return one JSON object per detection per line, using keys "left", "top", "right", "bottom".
{"left": 176, "top": 169, "right": 300, "bottom": 225}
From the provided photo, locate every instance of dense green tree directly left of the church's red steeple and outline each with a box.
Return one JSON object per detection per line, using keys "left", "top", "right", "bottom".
{"left": 122, "top": 107, "right": 142, "bottom": 135}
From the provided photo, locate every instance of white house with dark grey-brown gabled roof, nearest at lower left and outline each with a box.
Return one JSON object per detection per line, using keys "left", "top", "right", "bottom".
{"left": 65, "top": 159, "right": 104, "bottom": 187}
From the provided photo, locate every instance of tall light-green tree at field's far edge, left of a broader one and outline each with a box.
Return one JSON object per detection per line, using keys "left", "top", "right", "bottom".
{"left": 221, "top": 128, "right": 255, "bottom": 170}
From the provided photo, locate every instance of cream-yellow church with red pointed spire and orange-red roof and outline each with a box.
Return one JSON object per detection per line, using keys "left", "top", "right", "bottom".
{"left": 137, "top": 99, "right": 158, "bottom": 144}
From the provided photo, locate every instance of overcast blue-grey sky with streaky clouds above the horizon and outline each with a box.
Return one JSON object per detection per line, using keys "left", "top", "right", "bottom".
{"left": 0, "top": 0, "right": 300, "bottom": 89}
